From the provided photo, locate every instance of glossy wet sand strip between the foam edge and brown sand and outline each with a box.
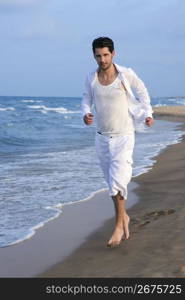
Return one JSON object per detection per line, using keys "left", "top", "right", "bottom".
{"left": 0, "top": 182, "right": 138, "bottom": 278}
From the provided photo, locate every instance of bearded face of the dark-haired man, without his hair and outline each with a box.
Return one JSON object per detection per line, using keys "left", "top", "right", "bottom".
{"left": 94, "top": 47, "right": 115, "bottom": 71}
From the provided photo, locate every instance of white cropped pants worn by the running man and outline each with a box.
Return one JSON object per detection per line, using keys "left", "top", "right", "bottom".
{"left": 95, "top": 133, "right": 135, "bottom": 200}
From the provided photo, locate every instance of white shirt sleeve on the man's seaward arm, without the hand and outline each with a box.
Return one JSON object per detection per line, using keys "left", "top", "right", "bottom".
{"left": 81, "top": 76, "right": 92, "bottom": 116}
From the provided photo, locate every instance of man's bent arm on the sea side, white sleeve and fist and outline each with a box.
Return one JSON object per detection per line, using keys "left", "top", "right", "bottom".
{"left": 81, "top": 77, "right": 93, "bottom": 125}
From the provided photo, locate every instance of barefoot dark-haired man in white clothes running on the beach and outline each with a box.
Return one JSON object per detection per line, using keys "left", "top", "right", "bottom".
{"left": 82, "top": 37, "right": 153, "bottom": 247}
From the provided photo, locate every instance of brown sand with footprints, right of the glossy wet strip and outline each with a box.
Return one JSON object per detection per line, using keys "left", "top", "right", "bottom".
{"left": 37, "top": 115, "right": 185, "bottom": 278}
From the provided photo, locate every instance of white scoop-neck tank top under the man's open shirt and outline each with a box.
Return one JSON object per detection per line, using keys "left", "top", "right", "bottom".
{"left": 93, "top": 73, "right": 134, "bottom": 136}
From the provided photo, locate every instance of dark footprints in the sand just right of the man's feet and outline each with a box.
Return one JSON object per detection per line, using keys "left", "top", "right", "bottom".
{"left": 131, "top": 209, "right": 175, "bottom": 227}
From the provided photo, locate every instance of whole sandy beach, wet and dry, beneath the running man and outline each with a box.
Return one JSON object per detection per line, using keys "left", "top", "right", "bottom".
{"left": 0, "top": 107, "right": 185, "bottom": 278}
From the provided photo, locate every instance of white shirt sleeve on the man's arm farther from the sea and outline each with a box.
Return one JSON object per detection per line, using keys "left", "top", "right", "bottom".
{"left": 128, "top": 68, "right": 153, "bottom": 118}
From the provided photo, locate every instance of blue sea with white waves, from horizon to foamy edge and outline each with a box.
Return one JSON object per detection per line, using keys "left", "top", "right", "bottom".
{"left": 0, "top": 96, "right": 185, "bottom": 247}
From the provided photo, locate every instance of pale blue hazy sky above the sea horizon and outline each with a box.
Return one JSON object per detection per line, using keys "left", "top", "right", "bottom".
{"left": 0, "top": 0, "right": 185, "bottom": 97}
